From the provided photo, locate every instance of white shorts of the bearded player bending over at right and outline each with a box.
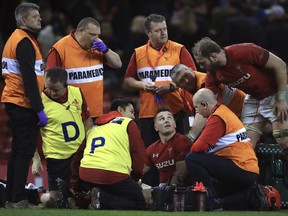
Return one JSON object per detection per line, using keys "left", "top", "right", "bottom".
{"left": 241, "top": 87, "right": 288, "bottom": 125}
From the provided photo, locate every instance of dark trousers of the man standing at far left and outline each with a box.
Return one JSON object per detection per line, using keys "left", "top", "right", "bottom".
{"left": 5, "top": 103, "right": 39, "bottom": 202}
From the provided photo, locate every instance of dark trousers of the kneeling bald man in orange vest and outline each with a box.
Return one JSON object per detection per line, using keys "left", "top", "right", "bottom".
{"left": 186, "top": 152, "right": 258, "bottom": 210}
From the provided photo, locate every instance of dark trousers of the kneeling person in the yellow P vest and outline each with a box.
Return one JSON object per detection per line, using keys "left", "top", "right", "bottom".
{"left": 84, "top": 177, "right": 146, "bottom": 210}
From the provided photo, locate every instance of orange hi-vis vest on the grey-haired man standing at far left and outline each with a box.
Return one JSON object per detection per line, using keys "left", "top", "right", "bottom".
{"left": 1, "top": 29, "right": 44, "bottom": 108}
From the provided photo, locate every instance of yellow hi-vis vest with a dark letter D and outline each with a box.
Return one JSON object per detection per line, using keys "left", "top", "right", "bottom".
{"left": 40, "top": 86, "right": 85, "bottom": 159}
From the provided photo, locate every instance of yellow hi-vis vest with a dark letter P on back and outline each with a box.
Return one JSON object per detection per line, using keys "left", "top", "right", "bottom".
{"left": 80, "top": 117, "right": 132, "bottom": 174}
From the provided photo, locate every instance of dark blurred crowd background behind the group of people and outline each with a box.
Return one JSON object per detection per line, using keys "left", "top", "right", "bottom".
{"left": 0, "top": 0, "right": 288, "bottom": 159}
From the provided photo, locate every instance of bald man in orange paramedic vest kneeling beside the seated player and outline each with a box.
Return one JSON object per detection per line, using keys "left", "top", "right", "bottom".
{"left": 186, "top": 88, "right": 267, "bottom": 210}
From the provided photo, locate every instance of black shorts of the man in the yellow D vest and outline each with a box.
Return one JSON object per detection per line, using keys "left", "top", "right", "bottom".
{"left": 46, "top": 156, "right": 73, "bottom": 190}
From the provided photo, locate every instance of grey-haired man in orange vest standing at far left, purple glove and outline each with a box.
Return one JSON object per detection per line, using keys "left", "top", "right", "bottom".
{"left": 1, "top": 3, "right": 48, "bottom": 208}
